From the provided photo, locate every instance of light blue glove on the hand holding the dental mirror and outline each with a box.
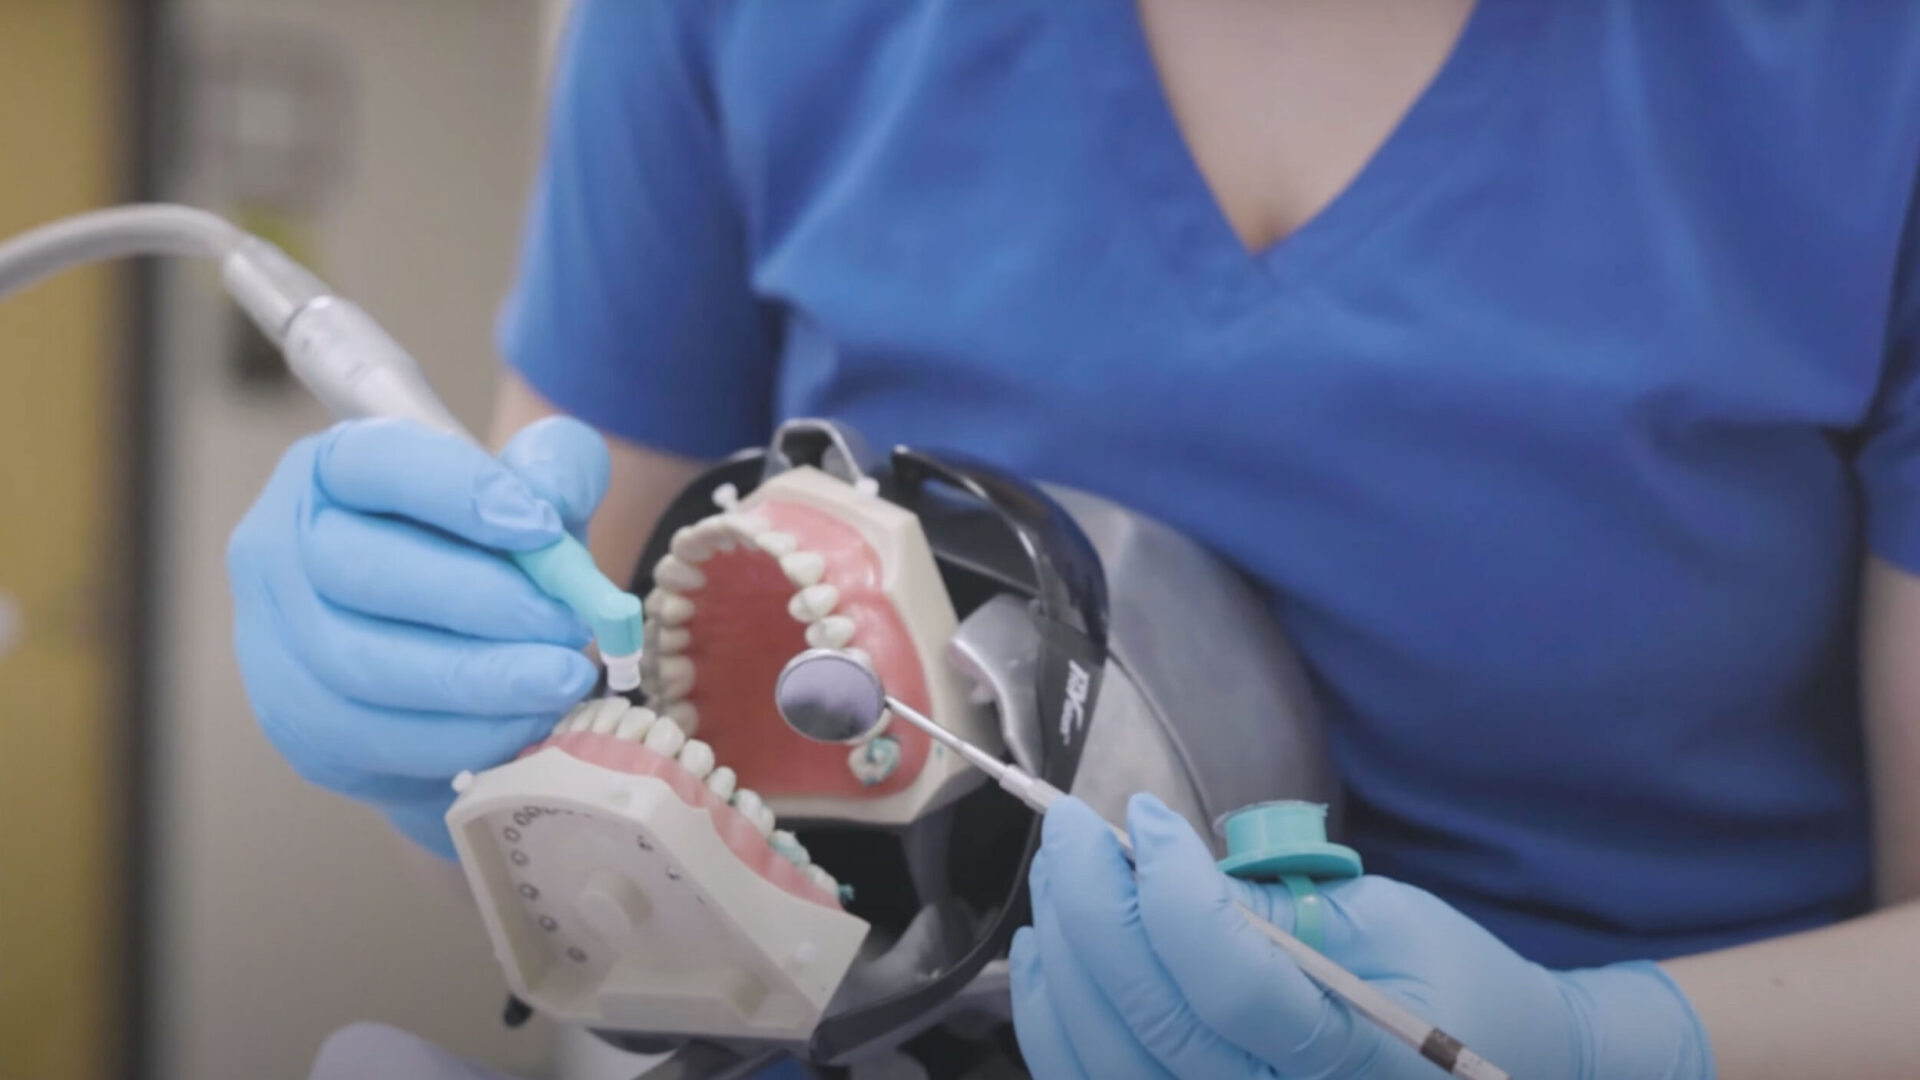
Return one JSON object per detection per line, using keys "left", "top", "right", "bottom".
{"left": 1012, "top": 796, "right": 1713, "bottom": 1080}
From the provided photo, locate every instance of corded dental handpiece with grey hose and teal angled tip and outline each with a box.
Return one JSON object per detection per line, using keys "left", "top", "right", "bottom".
{"left": 0, "top": 204, "right": 641, "bottom": 692}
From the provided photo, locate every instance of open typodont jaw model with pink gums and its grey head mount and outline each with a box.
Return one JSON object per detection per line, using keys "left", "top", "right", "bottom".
{"left": 447, "top": 421, "right": 1331, "bottom": 1063}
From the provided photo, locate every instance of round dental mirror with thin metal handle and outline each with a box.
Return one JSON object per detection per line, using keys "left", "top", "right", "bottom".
{"left": 774, "top": 650, "right": 1511, "bottom": 1080}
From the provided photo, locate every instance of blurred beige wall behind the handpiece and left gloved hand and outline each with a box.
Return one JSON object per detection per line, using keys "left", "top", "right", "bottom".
{"left": 154, "top": 0, "right": 551, "bottom": 1080}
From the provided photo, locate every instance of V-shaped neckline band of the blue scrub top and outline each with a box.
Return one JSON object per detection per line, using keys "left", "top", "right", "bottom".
{"left": 1081, "top": 0, "right": 1551, "bottom": 317}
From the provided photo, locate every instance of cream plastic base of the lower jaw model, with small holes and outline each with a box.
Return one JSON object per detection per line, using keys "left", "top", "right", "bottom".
{"left": 447, "top": 738, "right": 868, "bottom": 1040}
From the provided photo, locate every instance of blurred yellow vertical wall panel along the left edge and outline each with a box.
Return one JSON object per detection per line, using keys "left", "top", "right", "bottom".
{"left": 0, "top": 0, "right": 123, "bottom": 1080}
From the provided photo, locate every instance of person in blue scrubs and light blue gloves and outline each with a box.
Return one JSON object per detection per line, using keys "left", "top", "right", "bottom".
{"left": 234, "top": 0, "right": 1920, "bottom": 1080}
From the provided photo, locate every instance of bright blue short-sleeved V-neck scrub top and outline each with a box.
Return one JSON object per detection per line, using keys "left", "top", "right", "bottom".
{"left": 499, "top": 0, "right": 1920, "bottom": 967}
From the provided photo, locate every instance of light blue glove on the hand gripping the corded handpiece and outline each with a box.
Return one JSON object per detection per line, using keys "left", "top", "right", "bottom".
{"left": 227, "top": 417, "right": 609, "bottom": 857}
